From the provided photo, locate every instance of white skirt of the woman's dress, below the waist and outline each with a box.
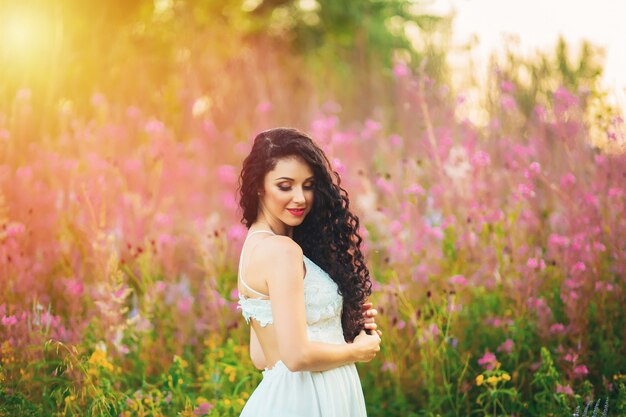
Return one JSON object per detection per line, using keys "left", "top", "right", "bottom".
{"left": 241, "top": 361, "right": 367, "bottom": 417}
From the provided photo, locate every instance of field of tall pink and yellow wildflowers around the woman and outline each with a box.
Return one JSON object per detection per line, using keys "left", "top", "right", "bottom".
{"left": 0, "top": 1, "right": 626, "bottom": 417}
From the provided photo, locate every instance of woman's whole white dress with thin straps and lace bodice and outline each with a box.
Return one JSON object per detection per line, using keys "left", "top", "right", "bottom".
{"left": 239, "top": 230, "right": 367, "bottom": 417}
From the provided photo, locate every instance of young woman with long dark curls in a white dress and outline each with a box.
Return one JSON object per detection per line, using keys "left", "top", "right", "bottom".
{"left": 238, "top": 128, "right": 381, "bottom": 417}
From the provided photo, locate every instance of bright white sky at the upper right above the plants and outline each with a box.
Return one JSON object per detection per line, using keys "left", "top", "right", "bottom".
{"left": 430, "top": 0, "right": 626, "bottom": 116}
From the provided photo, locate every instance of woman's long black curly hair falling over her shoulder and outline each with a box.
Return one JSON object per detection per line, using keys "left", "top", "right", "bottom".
{"left": 238, "top": 128, "right": 372, "bottom": 342}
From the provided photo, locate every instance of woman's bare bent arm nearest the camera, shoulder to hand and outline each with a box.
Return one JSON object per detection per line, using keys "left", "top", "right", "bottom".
{"left": 257, "top": 236, "right": 380, "bottom": 371}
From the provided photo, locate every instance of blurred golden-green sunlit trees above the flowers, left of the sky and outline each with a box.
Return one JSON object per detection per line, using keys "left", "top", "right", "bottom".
{"left": 0, "top": 0, "right": 449, "bottom": 136}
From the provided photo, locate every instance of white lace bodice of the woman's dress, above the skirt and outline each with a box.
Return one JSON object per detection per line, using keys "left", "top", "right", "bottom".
{"left": 238, "top": 231, "right": 345, "bottom": 343}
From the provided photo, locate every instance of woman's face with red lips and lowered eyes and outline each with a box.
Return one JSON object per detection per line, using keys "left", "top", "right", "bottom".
{"left": 259, "top": 157, "right": 314, "bottom": 232}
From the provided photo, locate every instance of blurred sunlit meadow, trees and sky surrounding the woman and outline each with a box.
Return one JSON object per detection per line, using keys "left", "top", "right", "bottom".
{"left": 0, "top": 0, "right": 626, "bottom": 417}
